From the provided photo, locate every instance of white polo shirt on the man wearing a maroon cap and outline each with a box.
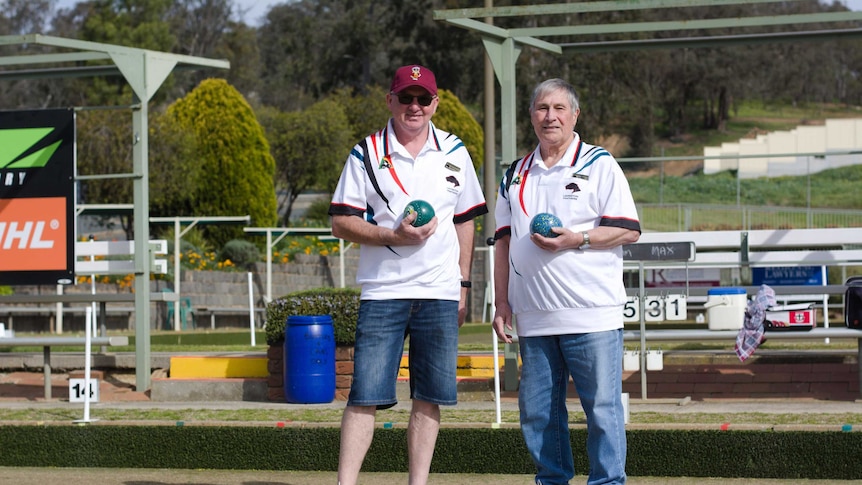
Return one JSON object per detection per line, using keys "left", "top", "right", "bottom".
{"left": 329, "top": 120, "right": 488, "bottom": 301}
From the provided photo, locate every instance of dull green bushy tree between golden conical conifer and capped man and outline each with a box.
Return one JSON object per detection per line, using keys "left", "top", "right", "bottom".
{"left": 259, "top": 99, "right": 354, "bottom": 226}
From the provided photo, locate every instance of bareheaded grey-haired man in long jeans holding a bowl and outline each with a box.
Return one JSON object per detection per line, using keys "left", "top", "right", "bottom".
{"left": 493, "top": 79, "right": 640, "bottom": 485}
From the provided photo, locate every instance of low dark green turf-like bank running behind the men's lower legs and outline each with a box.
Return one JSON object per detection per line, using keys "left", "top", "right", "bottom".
{"left": 0, "top": 424, "right": 862, "bottom": 480}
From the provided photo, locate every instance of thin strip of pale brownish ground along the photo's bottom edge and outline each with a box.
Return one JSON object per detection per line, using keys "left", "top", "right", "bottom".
{"left": 0, "top": 467, "right": 862, "bottom": 485}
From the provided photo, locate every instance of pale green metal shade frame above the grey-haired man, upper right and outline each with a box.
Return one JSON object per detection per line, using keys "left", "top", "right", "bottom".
{"left": 434, "top": 0, "right": 862, "bottom": 191}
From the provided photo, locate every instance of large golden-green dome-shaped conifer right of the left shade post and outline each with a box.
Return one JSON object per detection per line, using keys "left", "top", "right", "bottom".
{"left": 167, "top": 79, "right": 277, "bottom": 246}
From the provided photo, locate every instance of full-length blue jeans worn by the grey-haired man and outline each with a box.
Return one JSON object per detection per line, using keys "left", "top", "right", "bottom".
{"left": 518, "top": 330, "right": 626, "bottom": 485}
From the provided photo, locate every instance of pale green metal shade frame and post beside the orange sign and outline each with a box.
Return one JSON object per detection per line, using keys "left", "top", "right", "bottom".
{"left": 0, "top": 34, "right": 230, "bottom": 390}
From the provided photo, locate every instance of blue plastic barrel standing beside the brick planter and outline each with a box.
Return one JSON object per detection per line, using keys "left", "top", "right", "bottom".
{"left": 283, "top": 315, "right": 335, "bottom": 404}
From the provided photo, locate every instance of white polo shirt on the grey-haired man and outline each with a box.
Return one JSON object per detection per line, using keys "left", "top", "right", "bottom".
{"left": 495, "top": 133, "right": 640, "bottom": 337}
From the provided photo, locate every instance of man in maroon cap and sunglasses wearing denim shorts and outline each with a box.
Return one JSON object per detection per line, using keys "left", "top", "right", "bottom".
{"left": 329, "top": 65, "right": 488, "bottom": 485}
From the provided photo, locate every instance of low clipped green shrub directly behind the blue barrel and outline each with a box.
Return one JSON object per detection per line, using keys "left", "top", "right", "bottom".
{"left": 264, "top": 288, "right": 359, "bottom": 345}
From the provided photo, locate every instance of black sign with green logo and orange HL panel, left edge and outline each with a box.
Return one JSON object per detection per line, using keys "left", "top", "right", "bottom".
{"left": 0, "top": 109, "right": 75, "bottom": 285}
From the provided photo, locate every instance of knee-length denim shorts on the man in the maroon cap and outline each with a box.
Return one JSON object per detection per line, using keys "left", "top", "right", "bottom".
{"left": 347, "top": 300, "right": 458, "bottom": 409}
